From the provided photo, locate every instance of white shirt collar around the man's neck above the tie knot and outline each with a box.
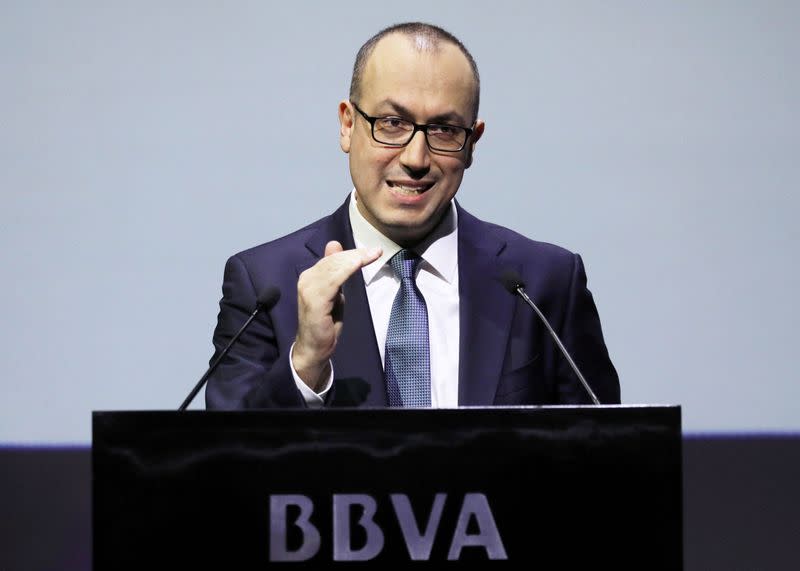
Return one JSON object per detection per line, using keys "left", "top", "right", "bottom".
{"left": 349, "top": 189, "right": 458, "bottom": 285}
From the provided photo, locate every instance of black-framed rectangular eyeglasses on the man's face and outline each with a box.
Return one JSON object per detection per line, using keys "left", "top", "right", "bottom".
{"left": 351, "top": 101, "right": 472, "bottom": 153}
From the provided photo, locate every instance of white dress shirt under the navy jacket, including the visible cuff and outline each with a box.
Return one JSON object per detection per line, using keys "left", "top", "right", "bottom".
{"left": 289, "top": 191, "right": 460, "bottom": 408}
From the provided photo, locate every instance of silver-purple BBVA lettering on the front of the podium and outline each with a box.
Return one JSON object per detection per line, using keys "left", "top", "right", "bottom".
{"left": 269, "top": 493, "right": 508, "bottom": 562}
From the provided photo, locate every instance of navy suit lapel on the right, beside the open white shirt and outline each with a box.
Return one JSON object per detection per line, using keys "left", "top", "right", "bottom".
{"left": 458, "top": 206, "right": 514, "bottom": 406}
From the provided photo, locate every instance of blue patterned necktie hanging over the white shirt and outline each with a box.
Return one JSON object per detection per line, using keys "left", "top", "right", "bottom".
{"left": 384, "top": 250, "right": 431, "bottom": 408}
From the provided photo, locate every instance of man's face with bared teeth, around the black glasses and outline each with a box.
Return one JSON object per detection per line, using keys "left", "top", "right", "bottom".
{"left": 339, "top": 34, "right": 484, "bottom": 246}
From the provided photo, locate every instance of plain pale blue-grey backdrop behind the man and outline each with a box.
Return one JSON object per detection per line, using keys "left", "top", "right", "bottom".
{"left": 0, "top": 0, "right": 800, "bottom": 444}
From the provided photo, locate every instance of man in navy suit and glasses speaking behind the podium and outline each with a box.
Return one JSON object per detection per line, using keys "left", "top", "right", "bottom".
{"left": 206, "top": 23, "right": 620, "bottom": 409}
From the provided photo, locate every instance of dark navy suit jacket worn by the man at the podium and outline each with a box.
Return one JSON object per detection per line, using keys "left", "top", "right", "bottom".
{"left": 206, "top": 199, "right": 620, "bottom": 409}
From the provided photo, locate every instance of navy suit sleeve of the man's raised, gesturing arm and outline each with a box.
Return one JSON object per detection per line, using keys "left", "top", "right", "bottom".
{"left": 206, "top": 255, "right": 306, "bottom": 409}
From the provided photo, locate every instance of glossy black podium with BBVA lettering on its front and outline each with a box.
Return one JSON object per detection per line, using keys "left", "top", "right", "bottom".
{"left": 92, "top": 406, "right": 683, "bottom": 571}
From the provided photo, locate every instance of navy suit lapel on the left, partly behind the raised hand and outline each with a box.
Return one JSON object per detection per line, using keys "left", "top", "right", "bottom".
{"left": 297, "top": 198, "right": 388, "bottom": 407}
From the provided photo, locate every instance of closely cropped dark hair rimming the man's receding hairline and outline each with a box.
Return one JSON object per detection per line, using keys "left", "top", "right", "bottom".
{"left": 350, "top": 22, "right": 480, "bottom": 120}
